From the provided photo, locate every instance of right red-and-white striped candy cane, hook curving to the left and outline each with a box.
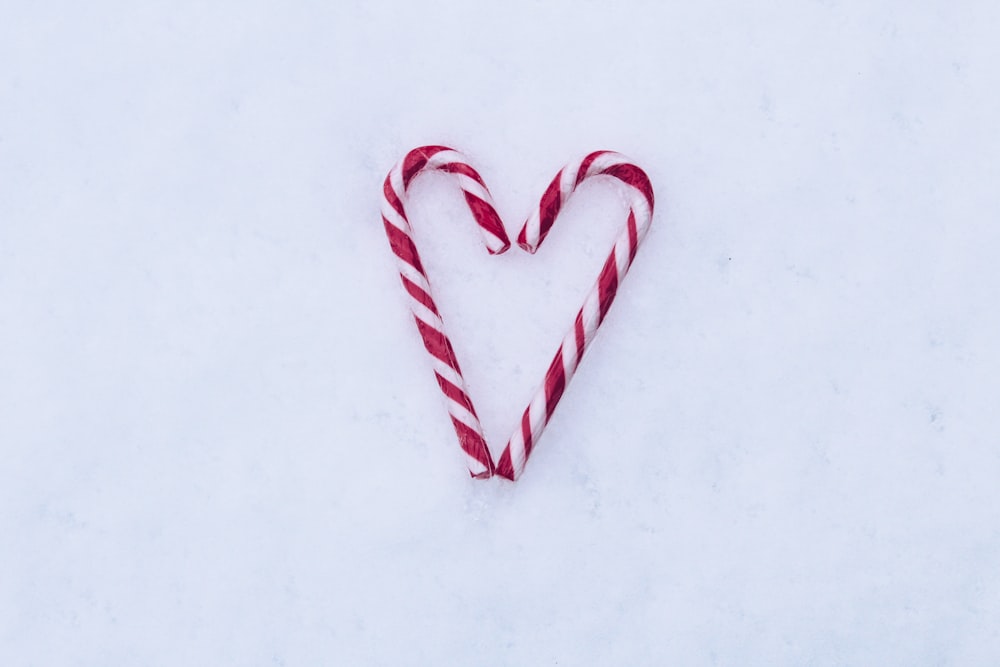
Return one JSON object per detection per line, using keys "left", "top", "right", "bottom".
{"left": 496, "top": 151, "right": 653, "bottom": 480}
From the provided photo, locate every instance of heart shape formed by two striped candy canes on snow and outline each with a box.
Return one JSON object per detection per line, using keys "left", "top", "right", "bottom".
{"left": 382, "top": 146, "right": 653, "bottom": 481}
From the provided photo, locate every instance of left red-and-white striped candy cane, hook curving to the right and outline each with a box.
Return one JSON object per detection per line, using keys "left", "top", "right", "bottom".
{"left": 382, "top": 146, "right": 510, "bottom": 478}
